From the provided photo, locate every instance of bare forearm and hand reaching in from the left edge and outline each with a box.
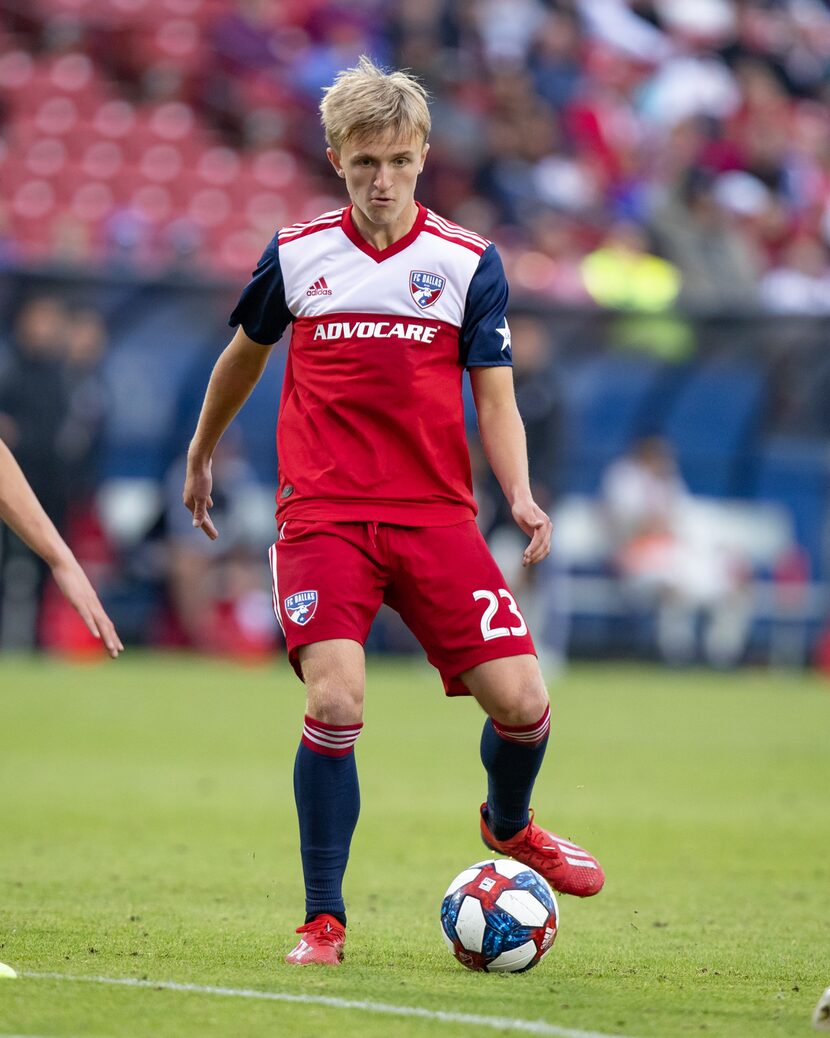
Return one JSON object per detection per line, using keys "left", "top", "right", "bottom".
{"left": 0, "top": 440, "right": 123, "bottom": 659}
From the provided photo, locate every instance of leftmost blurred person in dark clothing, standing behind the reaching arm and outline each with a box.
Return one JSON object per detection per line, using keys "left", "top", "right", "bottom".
{"left": 0, "top": 295, "right": 70, "bottom": 649}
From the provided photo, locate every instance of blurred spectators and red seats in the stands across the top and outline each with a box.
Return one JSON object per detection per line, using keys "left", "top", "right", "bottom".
{"left": 0, "top": 0, "right": 830, "bottom": 313}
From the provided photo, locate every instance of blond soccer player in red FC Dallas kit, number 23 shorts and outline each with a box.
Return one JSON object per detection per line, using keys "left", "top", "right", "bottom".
{"left": 184, "top": 57, "right": 604, "bottom": 965}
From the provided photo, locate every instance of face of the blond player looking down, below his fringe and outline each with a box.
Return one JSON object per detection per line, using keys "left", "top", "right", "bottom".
{"left": 326, "top": 134, "right": 430, "bottom": 247}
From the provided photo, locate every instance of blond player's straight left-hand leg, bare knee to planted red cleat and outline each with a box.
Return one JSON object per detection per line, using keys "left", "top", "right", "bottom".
{"left": 286, "top": 638, "right": 365, "bottom": 965}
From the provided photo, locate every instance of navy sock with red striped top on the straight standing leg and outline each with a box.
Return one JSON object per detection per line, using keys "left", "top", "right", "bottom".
{"left": 294, "top": 716, "right": 363, "bottom": 926}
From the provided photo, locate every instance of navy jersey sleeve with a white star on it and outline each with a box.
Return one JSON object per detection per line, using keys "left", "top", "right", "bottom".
{"left": 459, "top": 245, "right": 513, "bottom": 367}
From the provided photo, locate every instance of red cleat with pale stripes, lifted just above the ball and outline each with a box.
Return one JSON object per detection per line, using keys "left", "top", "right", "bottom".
{"left": 481, "top": 803, "right": 605, "bottom": 898}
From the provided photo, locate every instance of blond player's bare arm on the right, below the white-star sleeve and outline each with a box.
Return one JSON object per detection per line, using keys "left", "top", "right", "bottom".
{"left": 470, "top": 366, "right": 552, "bottom": 566}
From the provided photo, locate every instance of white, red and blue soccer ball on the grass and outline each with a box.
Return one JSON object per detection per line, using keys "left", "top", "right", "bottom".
{"left": 441, "top": 857, "right": 559, "bottom": 973}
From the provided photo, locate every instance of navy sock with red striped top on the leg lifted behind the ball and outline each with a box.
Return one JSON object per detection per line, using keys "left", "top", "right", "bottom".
{"left": 481, "top": 707, "right": 551, "bottom": 840}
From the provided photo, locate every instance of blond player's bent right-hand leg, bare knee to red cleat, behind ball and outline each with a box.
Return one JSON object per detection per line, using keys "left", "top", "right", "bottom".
{"left": 462, "top": 656, "right": 605, "bottom": 897}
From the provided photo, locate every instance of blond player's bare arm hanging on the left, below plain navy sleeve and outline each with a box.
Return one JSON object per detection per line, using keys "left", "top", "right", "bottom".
{"left": 182, "top": 328, "right": 271, "bottom": 541}
